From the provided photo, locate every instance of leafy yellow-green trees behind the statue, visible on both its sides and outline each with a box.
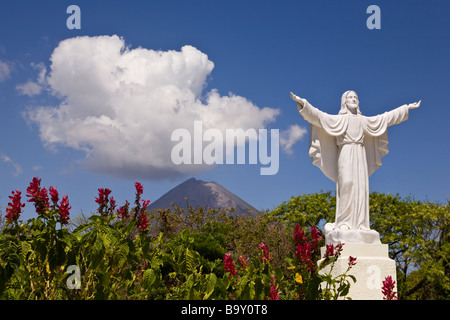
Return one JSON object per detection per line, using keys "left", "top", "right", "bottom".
{"left": 271, "top": 192, "right": 450, "bottom": 299}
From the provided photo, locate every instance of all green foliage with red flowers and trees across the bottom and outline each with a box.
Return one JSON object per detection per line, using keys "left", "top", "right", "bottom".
{"left": 0, "top": 178, "right": 449, "bottom": 300}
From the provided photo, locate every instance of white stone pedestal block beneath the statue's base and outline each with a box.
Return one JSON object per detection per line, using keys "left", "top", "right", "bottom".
{"left": 319, "top": 243, "right": 397, "bottom": 300}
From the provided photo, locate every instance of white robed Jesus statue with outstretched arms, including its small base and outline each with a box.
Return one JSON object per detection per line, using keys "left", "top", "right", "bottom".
{"left": 291, "top": 91, "right": 421, "bottom": 243}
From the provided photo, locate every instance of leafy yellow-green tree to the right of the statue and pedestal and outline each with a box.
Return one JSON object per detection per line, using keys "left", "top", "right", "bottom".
{"left": 370, "top": 192, "right": 450, "bottom": 299}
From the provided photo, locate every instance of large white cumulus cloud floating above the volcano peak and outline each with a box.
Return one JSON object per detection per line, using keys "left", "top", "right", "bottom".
{"left": 24, "top": 36, "right": 279, "bottom": 179}
